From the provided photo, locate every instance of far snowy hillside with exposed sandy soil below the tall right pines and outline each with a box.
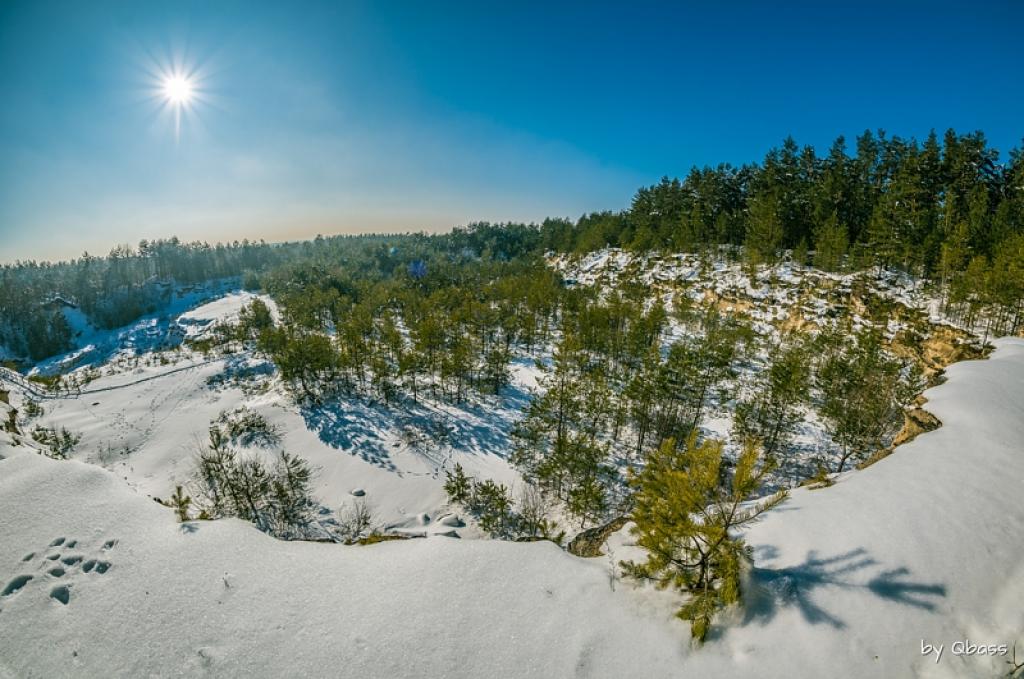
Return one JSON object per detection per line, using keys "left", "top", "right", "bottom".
{"left": 548, "top": 248, "right": 985, "bottom": 490}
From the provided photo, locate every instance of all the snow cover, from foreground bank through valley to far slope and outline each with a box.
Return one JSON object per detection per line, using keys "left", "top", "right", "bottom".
{"left": 0, "top": 245, "right": 1024, "bottom": 677}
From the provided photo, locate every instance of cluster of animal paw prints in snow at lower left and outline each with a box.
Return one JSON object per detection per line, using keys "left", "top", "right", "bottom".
{"left": 0, "top": 537, "right": 118, "bottom": 605}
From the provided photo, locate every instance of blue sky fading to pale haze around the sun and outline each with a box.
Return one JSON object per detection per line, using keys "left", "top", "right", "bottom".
{"left": 0, "top": 0, "right": 1024, "bottom": 261}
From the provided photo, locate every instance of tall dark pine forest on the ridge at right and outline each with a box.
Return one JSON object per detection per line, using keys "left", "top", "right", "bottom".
{"left": 545, "top": 130, "right": 1024, "bottom": 270}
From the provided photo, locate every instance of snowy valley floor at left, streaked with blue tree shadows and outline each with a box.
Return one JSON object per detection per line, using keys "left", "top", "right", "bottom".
{"left": 12, "top": 292, "right": 538, "bottom": 533}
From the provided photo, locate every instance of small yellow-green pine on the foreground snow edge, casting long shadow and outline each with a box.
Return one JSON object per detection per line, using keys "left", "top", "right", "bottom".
{"left": 622, "top": 435, "right": 786, "bottom": 641}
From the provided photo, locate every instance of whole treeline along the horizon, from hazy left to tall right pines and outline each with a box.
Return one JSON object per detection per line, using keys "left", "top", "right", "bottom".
{"left": 0, "top": 130, "right": 1024, "bottom": 360}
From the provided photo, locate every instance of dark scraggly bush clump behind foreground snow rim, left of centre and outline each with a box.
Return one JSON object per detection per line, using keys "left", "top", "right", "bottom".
{"left": 193, "top": 436, "right": 315, "bottom": 539}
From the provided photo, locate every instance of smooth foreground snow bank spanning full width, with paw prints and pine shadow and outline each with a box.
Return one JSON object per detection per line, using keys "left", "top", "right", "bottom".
{"left": 0, "top": 340, "right": 1024, "bottom": 677}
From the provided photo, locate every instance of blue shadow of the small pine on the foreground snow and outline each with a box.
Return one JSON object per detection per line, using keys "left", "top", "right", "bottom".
{"left": 743, "top": 545, "right": 946, "bottom": 629}
